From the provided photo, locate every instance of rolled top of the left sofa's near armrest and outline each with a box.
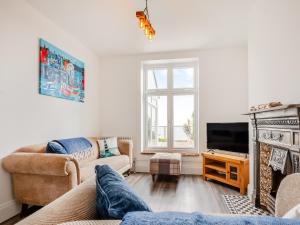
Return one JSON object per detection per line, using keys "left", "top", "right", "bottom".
{"left": 3, "top": 152, "right": 80, "bottom": 184}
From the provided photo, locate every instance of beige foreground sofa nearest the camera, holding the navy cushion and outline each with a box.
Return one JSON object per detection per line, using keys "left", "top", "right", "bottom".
{"left": 17, "top": 173, "right": 300, "bottom": 225}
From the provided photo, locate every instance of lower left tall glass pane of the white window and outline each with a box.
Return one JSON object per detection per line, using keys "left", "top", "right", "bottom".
{"left": 147, "top": 96, "right": 168, "bottom": 147}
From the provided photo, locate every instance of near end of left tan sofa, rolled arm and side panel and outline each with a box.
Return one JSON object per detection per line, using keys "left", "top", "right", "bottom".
{"left": 3, "top": 152, "right": 80, "bottom": 205}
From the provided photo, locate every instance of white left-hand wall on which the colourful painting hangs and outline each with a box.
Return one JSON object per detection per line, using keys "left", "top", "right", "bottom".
{"left": 0, "top": 0, "right": 100, "bottom": 222}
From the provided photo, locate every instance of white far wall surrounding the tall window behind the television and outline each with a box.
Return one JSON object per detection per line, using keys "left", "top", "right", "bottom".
{"left": 100, "top": 47, "right": 248, "bottom": 174}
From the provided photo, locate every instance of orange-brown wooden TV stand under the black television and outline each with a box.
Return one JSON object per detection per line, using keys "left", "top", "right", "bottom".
{"left": 202, "top": 152, "right": 249, "bottom": 195}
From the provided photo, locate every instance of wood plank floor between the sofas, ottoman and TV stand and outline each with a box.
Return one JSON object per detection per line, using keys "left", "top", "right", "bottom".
{"left": 1, "top": 173, "right": 239, "bottom": 225}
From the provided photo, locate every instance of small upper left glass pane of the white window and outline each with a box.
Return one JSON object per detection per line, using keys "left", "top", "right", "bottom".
{"left": 147, "top": 69, "right": 168, "bottom": 89}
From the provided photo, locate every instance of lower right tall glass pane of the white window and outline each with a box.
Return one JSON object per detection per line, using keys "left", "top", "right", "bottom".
{"left": 173, "top": 95, "right": 195, "bottom": 148}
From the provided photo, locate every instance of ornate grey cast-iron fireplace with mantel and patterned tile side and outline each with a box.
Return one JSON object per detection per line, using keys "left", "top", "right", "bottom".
{"left": 248, "top": 105, "right": 300, "bottom": 214}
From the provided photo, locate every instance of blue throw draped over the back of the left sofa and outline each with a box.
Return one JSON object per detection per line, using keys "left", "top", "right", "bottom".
{"left": 55, "top": 137, "right": 92, "bottom": 154}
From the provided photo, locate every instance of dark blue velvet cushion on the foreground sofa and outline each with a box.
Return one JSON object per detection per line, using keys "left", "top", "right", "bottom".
{"left": 95, "top": 165, "right": 151, "bottom": 219}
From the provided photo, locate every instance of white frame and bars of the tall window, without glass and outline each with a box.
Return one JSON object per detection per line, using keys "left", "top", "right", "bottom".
{"left": 141, "top": 59, "right": 199, "bottom": 153}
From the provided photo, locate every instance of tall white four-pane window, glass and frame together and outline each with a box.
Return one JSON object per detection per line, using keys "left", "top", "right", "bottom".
{"left": 143, "top": 61, "right": 198, "bottom": 151}
